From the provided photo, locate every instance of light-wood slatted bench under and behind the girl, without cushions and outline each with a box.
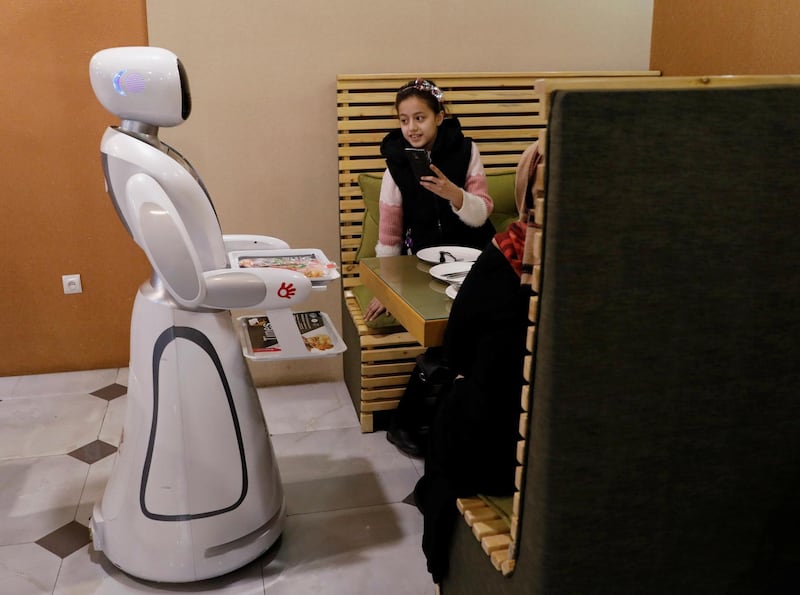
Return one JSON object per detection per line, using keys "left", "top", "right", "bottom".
{"left": 337, "top": 72, "right": 656, "bottom": 432}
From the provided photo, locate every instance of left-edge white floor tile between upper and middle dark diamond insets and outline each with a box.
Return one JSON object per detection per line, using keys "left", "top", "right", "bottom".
{"left": 0, "top": 394, "right": 108, "bottom": 459}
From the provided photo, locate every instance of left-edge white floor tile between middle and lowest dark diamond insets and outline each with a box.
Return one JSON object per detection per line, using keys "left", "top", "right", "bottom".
{"left": 0, "top": 455, "right": 89, "bottom": 545}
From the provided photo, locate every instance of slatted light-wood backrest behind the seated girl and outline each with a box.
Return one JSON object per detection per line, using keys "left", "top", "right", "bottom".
{"left": 336, "top": 71, "right": 658, "bottom": 289}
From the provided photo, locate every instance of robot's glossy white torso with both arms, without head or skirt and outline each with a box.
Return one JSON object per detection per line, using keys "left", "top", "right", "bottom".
{"left": 100, "top": 128, "right": 312, "bottom": 309}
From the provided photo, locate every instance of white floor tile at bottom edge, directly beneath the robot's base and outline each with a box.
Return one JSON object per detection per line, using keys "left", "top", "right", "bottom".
{"left": 53, "top": 545, "right": 264, "bottom": 595}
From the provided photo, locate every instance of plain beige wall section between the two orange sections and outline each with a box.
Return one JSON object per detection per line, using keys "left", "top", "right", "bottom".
{"left": 147, "top": 0, "right": 652, "bottom": 384}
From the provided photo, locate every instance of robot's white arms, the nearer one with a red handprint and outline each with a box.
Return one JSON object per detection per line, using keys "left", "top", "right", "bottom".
{"left": 126, "top": 173, "right": 312, "bottom": 309}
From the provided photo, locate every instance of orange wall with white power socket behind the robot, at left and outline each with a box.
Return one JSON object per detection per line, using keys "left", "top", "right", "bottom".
{"left": 0, "top": 0, "right": 149, "bottom": 376}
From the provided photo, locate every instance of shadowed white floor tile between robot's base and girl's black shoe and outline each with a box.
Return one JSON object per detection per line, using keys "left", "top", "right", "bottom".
{"left": 272, "top": 427, "right": 419, "bottom": 515}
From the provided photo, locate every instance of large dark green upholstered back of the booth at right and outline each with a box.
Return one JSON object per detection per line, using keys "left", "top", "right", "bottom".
{"left": 519, "top": 87, "right": 800, "bottom": 594}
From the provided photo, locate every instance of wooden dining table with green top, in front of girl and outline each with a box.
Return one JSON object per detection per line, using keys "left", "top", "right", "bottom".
{"left": 358, "top": 256, "right": 453, "bottom": 347}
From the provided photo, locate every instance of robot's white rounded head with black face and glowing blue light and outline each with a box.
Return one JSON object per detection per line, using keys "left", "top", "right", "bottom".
{"left": 89, "top": 47, "right": 192, "bottom": 126}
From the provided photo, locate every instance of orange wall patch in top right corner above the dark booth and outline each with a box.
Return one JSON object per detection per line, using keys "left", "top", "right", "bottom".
{"left": 650, "top": 0, "right": 800, "bottom": 76}
